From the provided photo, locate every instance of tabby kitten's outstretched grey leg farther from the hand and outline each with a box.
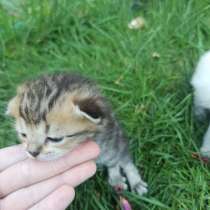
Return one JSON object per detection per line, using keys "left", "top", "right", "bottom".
{"left": 122, "top": 161, "right": 147, "bottom": 195}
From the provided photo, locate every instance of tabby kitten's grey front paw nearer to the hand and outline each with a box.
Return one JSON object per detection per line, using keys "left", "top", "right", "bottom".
{"left": 108, "top": 164, "right": 128, "bottom": 191}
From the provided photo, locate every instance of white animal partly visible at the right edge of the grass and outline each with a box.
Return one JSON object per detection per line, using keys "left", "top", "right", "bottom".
{"left": 191, "top": 51, "right": 210, "bottom": 157}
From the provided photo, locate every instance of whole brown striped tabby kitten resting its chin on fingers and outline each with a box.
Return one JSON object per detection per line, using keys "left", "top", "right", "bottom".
{"left": 7, "top": 73, "right": 147, "bottom": 195}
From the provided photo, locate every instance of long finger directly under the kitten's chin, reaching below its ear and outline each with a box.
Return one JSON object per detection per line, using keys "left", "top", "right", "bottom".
{"left": 0, "top": 142, "right": 99, "bottom": 197}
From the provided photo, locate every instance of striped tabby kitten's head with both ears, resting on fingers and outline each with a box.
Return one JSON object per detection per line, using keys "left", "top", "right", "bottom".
{"left": 7, "top": 74, "right": 107, "bottom": 160}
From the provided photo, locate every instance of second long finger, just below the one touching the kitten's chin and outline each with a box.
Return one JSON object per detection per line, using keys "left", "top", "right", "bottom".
{"left": 1, "top": 161, "right": 96, "bottom": 209}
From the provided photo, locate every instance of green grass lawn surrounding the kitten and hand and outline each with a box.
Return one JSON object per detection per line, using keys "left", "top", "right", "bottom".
{"left": 0, "top": 0, "right": 210, "bottom": 210}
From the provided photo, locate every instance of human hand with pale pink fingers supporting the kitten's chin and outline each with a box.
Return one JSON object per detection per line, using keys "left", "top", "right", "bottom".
{"left": 0, "top": 142, "right": 99, "bottom": 210}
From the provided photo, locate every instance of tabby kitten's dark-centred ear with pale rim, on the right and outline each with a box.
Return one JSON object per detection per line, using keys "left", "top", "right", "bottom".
{"left": 75, "top": 98, "right": 105, "bottom": 124}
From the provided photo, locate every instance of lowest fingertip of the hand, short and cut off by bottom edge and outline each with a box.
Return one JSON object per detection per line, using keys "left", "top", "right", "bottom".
{"left": 29, "top": 185, "right": 75, "bottom": 210}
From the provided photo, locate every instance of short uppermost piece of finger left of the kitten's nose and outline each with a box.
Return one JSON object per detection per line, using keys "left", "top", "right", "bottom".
{"left": 0, "top": 144, "right": 27, "bottom": 171}
